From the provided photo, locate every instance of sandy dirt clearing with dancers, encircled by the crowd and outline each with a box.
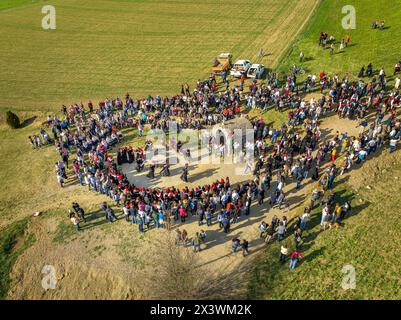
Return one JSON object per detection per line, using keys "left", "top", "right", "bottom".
{"left": 122, "top": 117, "right": 253, "bottom": 188}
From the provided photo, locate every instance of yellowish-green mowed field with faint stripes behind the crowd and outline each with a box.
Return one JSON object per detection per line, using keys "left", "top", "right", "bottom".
{"left": 0, "top": 0, "right": 317, "bottom": 111}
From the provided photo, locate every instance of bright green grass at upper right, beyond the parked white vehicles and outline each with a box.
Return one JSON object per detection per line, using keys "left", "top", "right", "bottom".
{"left": 279, "top": 0, "right": 401, "bottom": 80}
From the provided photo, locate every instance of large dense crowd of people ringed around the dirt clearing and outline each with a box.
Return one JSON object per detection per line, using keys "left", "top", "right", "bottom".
{"left": 29, "top": 42, "right": 401, "bottom": 268}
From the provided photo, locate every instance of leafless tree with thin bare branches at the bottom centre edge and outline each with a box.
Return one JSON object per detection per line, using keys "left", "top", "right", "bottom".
{"left": 137, "top": 230, "right": 245, "bottom": 300}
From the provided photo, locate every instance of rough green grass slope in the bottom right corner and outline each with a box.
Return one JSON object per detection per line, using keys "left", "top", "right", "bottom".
{"left": 248, "top": 152, "right": 401, "bottom": 299}
